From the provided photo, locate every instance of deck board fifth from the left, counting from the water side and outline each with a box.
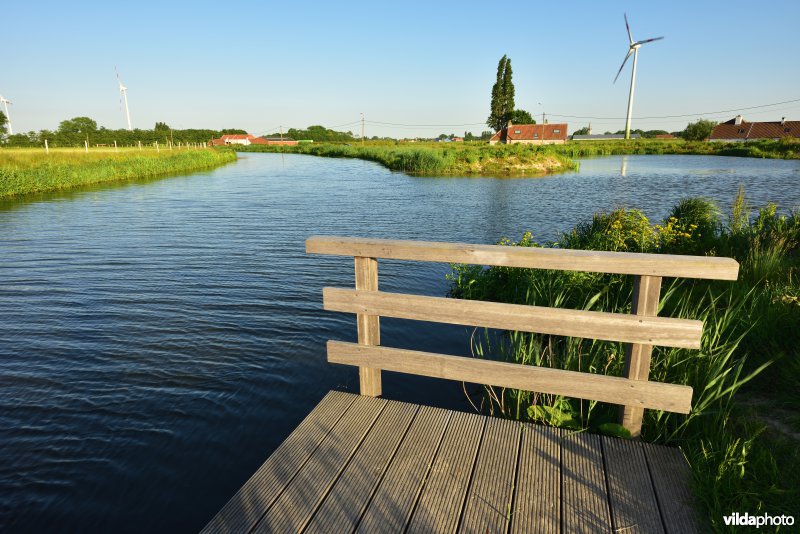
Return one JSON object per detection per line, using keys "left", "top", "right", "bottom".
{"left": 406, "top": 412, "right": 486, "bottom": 534}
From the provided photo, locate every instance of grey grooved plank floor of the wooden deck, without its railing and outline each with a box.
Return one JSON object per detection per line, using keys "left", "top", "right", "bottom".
{"left": 204, "top": 391, "right": 697, "bottom": 533}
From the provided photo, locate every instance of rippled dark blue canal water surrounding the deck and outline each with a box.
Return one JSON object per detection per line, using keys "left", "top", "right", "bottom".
{"left": 0, "top": 154, "right": 800, "bottom": 532}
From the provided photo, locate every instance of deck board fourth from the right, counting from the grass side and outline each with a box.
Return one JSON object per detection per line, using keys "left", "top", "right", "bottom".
{"left": 511, "top": 424, "right": 564, "bottom": 533}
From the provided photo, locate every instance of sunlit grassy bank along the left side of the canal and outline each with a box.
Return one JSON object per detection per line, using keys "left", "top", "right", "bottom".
{"left": 0, "top": 148, "right": 236, "bottom": 198}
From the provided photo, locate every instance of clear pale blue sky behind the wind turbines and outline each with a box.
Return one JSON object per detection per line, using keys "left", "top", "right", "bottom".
{"left": 6, "top": 0, "right": 800, "bottom": 137}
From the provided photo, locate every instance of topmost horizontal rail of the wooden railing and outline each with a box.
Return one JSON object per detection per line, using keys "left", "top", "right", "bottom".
{"left": 306, "top": 236, "right": 739, "bottom": 280}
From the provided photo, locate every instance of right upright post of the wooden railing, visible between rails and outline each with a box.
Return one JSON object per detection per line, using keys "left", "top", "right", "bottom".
{"left": 620, "top": 276, "right": 661, "bottom": 438}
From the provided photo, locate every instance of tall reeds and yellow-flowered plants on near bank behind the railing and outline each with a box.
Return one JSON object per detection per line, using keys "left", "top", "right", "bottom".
{"left": 449, "top": 191, "right": 800, "bottom": 530}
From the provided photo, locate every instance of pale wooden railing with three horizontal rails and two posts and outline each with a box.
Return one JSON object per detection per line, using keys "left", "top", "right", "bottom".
{"left": 306, "top": 236, "right": 739, "bottom": 436}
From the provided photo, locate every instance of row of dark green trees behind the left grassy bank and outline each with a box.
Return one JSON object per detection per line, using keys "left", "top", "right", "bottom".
{"left": 0, "top": 116, "right": 247, "bottom": 148}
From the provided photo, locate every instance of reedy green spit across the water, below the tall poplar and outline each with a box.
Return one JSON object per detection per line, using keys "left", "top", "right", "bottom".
{"left": 236, "top": 143, "right": 576, "bottom": 176}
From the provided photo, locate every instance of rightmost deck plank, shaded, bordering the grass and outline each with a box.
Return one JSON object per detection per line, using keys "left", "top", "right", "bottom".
{"left": 642, "top": 443, "right": 700, "bottom": 534}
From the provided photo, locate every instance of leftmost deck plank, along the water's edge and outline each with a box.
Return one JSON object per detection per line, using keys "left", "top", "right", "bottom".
{"left": 203, "top": 391, "right": 356, "bottom": 533}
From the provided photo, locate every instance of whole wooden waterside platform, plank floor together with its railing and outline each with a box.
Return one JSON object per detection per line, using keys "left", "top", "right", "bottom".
{"left": 204, "top": 237, "right": 738, "bottom": 534}
